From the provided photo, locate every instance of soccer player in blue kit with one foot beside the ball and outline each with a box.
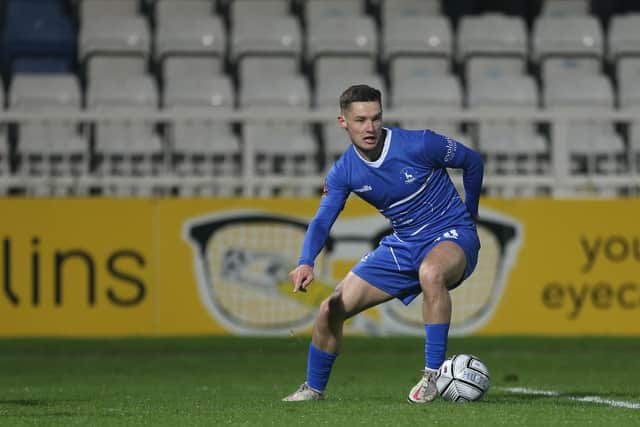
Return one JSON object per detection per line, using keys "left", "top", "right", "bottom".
{"left": 283, "top": 85, "right": 483, "bottom": 403}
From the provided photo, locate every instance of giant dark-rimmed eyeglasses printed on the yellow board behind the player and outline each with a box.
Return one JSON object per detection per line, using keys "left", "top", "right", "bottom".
{"left": 183, "top": 210, "right": 522, "bottom": 335}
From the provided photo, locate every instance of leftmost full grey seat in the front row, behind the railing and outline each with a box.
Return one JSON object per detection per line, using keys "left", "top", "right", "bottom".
{"left": 9, "top": 74, "right": 89, "bottom": 181}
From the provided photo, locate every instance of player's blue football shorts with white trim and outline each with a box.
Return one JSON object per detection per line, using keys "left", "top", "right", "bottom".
{"left": 351, "top": 227, "right": 480, "bottom": 305}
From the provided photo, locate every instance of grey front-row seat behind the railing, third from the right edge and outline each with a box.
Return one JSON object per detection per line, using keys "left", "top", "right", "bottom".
{"left": 467, "top": 75, "right": 549, "bottom": 180}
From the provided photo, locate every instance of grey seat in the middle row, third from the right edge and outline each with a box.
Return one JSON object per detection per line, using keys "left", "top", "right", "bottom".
{"left": 457, "top": 13, "right": 528, "bottom": 81}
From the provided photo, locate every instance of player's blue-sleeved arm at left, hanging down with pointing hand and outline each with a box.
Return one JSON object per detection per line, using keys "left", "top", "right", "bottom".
{"left": 289, "top": 169, "right": 349, "bottom": 293}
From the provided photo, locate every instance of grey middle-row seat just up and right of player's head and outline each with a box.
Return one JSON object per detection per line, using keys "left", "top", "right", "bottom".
{"left": 381, "top": 16, "right": 453, "bottom": 78}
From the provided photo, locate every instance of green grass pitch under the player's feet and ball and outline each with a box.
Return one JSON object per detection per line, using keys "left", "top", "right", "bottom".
{"left": 0, "top": 337, "right": 640, "bottom": 427}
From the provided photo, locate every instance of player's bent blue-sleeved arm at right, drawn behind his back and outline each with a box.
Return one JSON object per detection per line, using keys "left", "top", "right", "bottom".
{"left": 425, "top": 131, "right": 484, "bottom": 219}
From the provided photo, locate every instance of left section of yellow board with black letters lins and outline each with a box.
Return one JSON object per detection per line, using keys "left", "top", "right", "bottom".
{"left": 0, "top": 199, "right": 155, "bottom": 336}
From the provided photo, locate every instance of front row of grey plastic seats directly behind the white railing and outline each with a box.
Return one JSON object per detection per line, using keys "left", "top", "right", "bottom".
{"left": 3, "top": 70, "right": 640, "bottom": 179}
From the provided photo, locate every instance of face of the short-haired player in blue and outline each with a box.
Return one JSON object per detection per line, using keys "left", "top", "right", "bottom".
{"left": 338, "top": 101, "right": 384, "bottom": 160}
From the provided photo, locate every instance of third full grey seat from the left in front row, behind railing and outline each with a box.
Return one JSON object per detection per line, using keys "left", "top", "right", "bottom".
{"left": 163, "top": 76, "right": 240, "bottom": 195}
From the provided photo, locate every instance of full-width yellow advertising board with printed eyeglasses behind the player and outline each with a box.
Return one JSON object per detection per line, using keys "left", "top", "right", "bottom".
{"left": 0, "top": 198, "right": 640, "bottom": 336}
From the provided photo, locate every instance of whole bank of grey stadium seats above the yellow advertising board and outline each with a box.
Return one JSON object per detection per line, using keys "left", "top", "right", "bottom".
{"left": 0, "top": 0, "right": 640, "bottom": 197}
